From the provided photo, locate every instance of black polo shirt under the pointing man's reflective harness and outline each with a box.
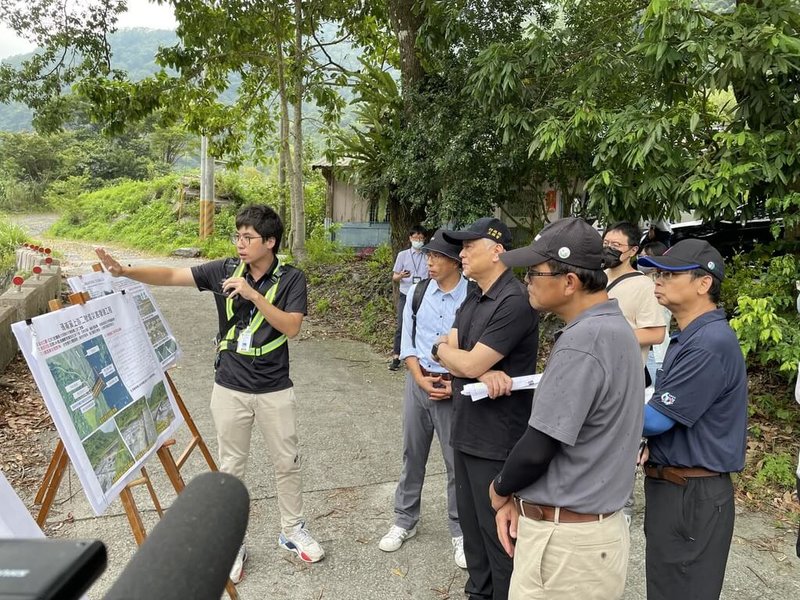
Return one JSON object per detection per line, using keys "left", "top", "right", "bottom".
{"left": 192, "top": 259, "right": 308, "bottom": 394}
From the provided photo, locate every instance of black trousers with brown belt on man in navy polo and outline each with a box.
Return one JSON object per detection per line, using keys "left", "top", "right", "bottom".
{"left": 644, "top": 474, "right": 734, "bottom": 600}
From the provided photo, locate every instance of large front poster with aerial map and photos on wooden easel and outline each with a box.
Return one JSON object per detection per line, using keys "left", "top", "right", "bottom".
{"left": 11, "top": 294, "right": 183, "bottom": 515}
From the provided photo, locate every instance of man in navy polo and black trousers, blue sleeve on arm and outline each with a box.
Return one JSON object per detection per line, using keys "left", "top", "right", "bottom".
{"left": 639, "top": 239, "right": 747, "bottom": 600}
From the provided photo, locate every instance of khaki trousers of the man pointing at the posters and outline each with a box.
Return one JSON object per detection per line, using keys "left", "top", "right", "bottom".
{"left": 211, "top": 384, "right": 303, "bottom": 531}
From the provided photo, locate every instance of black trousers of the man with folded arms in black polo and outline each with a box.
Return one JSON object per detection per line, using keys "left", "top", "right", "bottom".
{"left": 453, "top": 450, "right": 514, "bottom": 600}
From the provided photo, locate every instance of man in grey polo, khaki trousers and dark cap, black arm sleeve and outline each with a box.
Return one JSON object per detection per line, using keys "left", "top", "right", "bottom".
{"left": 489, "top": 218, "right": 644, "bottom": 600}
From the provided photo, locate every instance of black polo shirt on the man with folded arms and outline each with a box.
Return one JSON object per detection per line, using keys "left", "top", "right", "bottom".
{"left": 450, "top": 269, "right": 539, "bottom": 460}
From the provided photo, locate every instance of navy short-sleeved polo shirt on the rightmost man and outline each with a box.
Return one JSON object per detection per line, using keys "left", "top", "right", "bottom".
{"left": 648, "top": 310, "right": 747, "bottom": 473}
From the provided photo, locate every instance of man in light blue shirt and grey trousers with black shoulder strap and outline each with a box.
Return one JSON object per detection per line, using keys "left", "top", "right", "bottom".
{"left": 379, "top": 231, "right": 467, "bottom": 569}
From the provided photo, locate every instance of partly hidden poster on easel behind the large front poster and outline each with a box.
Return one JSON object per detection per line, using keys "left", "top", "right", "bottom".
{"left": 67, "top": 271, "right": 180, "bottom": 369}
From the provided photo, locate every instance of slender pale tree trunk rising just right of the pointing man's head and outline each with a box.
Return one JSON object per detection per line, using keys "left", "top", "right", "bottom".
{"left": 292, "top": 0, "right": 306, "bottom": 259}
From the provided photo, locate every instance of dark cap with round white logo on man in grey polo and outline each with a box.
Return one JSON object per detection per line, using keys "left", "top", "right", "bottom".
{"left": 500, "top": 217, "right": 603, "bottom": 271}
